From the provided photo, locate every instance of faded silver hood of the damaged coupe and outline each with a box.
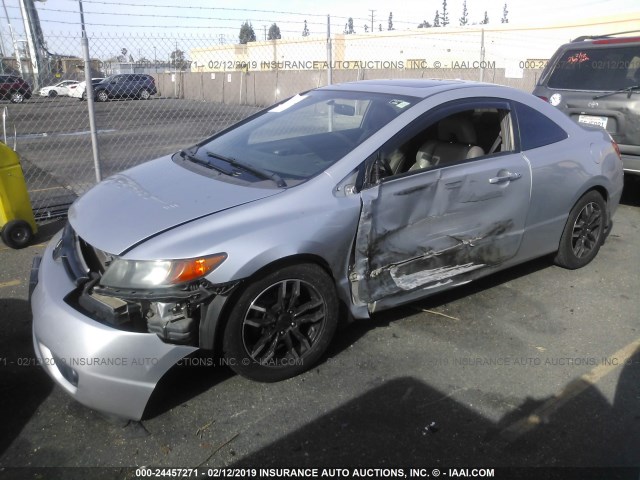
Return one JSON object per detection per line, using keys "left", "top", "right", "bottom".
{"left": 69, "top": 156, "right": 283, "bottom": 255}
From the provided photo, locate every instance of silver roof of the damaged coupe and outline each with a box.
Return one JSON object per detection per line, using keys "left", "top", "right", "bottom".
{"left": 320, "top": 79, "right": 500, "bottom": 98}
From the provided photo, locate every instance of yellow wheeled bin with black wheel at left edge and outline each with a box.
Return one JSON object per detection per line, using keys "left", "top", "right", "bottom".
{"left": 0, "top": 142, "right": 38, "bottom": 248}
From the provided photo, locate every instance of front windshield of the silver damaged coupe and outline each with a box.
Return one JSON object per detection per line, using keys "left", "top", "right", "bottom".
{"left": 189, "top": 90, "right": 418, "bottom": 186}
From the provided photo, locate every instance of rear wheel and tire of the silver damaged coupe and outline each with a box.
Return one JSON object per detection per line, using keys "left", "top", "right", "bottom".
{"left": 554, "top": 191, "right": 607, "bottom": 270}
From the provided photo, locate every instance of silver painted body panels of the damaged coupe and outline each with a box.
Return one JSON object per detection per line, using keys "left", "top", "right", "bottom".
{"left": 32, "top": 81, "right": 622, "bottom": 419}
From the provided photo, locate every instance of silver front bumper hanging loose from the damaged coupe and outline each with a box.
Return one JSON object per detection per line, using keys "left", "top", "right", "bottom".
{"left": 31, "top": 234, "right": 197, "bottom": 420}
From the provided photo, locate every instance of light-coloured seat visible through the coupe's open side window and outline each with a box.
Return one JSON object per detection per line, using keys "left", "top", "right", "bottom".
{"left": 409, "top": 115, "right": 485, "bottom": 171}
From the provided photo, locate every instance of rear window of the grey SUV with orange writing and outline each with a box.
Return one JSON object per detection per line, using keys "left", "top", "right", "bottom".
{"left": 547, "top": 45, "right": 640, "bottom": 91}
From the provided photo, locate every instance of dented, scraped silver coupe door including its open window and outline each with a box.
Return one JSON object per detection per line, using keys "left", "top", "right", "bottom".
{"left": 351, "top": 104, "right": 531, "bottom": 311}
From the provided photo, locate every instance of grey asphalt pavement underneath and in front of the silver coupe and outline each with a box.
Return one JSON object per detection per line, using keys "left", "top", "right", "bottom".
{"left": 0, "top": 182, "right": 640, "bottom": 478}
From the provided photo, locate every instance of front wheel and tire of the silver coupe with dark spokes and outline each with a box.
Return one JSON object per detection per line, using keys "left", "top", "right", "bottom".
{"left": 223, "top": 264, "right": 338, "bottom": 382}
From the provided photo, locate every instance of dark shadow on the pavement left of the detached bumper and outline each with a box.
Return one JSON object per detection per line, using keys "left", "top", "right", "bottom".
{"left": 0, "top": 298, "right": 53, "bottom": 455}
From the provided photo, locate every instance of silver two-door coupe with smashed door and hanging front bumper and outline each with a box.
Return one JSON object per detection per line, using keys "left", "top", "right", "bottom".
{"left": 31, "top": 80, "right": 623, "bottom": 419}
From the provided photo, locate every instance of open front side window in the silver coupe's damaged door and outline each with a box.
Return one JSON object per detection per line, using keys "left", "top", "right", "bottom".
{"left": 370, "top": 104, "right": 514, "bottom": 183}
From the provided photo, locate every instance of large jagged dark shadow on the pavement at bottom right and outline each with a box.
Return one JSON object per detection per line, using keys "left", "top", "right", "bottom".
{"left": 230, "top": 346, "right": 640, "bottom": 470}
